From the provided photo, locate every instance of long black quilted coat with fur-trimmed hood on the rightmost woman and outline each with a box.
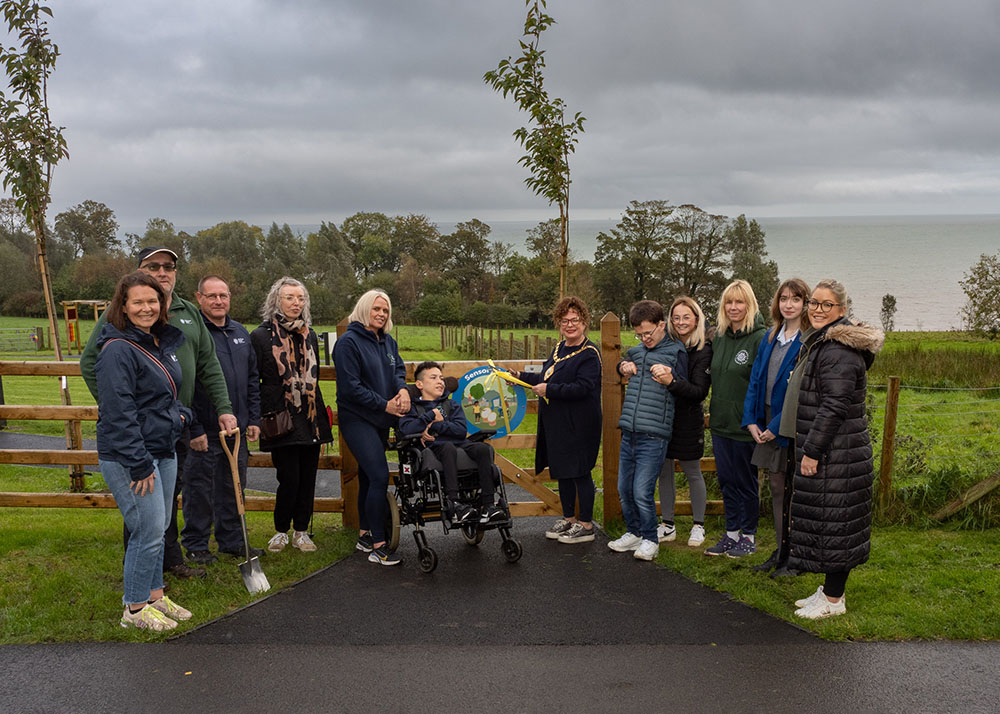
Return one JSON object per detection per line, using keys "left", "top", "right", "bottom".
{"left": 788, "top": 318, "right": 885, "bottom": 573}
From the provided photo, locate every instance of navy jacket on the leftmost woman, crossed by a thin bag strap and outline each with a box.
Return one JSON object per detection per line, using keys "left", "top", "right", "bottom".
{"left": 94, "top": 322, "right": 191, "bottom": 481}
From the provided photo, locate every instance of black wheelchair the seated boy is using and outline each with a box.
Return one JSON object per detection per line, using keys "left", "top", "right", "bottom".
{"left": 385, "top": 431, "right": 522, "bottom": 573}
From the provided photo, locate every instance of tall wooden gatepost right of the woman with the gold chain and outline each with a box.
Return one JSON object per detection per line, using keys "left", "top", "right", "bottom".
{"left": 601, "top": 312, "right": 624, "bottom": 526}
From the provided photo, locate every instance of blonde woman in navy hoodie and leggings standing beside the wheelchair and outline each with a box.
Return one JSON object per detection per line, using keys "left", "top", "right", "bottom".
{"left": 333, "top": 290, "right": 410, "bottom": 565}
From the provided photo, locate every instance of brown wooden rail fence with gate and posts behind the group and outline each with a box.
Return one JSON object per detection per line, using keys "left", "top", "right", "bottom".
{"left": 0, "top": 313, "right": 736, "bottom": 528}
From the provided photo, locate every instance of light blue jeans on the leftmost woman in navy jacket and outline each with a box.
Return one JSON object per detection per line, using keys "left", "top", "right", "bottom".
{"left": 99, "top": 457, "right": 177, "bottom": 605}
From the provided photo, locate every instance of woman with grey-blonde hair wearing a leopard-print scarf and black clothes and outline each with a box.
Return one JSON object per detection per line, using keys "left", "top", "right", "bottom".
{"left": 250, "top": 277, "right": 333, "bottom": 553}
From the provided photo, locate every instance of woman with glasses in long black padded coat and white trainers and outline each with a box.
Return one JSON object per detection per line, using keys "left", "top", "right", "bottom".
{"left": 780, "top": 279, "right": 885, "bottom": 620}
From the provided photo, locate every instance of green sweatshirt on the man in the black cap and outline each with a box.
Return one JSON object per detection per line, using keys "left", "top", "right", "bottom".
{"left": 80, "top": 295, "right": 233, "bottom": 414}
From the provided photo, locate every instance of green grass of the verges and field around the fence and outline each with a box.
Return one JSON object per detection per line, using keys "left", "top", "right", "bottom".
{"left": 0, "top": 318, "right": 1000, "bottom": 642}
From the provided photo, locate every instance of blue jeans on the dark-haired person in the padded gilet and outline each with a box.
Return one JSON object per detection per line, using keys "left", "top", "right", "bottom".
{"left": 618, "top": 429, "right": 667, "bottom": 543}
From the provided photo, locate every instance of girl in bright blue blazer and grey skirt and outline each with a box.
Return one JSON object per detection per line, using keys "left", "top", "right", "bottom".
{"left": 743, "top": 278, "right": 809, "bottom": 577}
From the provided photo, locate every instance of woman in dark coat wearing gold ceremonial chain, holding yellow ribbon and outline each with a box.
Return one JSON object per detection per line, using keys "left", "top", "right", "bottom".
{"left": 512, "top": 296, "right": 601, "bottom": 543}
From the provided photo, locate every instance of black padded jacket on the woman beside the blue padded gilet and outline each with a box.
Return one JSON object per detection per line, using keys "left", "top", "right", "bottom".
{"left": 667, "top": 339, "right": 712, "bottom": 461}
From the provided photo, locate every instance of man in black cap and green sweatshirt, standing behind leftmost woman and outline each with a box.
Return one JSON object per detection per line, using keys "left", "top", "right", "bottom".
{"left": 80, "top": 246, "right": 238, "bottom": 578}
